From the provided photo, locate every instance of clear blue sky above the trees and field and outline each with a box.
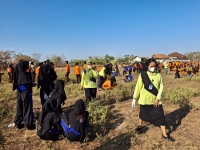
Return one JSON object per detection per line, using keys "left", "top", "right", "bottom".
{"left": 0, "top": 0, "right": 200, "bottom": 60}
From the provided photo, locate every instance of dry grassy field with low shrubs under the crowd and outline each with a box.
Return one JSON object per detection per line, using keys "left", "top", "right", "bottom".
{"left": 0, "top": 68, "right": 200, "bottom": 150}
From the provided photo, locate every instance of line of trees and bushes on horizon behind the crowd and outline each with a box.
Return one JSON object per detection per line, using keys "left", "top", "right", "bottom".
{"left": 0, "top": 50, "right": 200, "bottom": 69}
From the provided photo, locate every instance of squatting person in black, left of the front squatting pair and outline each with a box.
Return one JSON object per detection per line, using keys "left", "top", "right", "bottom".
{"left": 37, "top": 98, "right": 62, "bottom": 141}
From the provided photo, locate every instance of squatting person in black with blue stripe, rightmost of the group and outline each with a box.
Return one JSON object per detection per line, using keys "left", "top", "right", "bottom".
{"left": 61, "top": 99, "right": 89, "bottom": 142}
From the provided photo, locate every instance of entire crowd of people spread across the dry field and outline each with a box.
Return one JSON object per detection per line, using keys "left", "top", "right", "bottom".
{"left": 1, "top": 59, "right": 200, "bottom": 142}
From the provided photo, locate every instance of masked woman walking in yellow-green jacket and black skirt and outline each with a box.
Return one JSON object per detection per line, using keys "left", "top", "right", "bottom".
{"left": 133, "top": 58, "right": 174, "bottom": 142}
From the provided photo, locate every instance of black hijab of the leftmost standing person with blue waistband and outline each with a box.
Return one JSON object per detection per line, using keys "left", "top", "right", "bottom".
{"left": 13, "top": 61, "right": 32, "bottom": 90}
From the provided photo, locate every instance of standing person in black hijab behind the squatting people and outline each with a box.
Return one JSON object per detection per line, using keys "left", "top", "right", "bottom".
{"left": 38, "top": 61, "right": 57, "bottom": 105}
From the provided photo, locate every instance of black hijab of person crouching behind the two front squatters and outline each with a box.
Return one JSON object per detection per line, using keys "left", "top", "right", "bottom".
{"left": 52, "top": 80, "right": 67, "bottom": 102}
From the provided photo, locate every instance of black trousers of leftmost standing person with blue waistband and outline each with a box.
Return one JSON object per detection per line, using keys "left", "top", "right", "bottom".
{"left": 14, "top": 90, "right": 34, "bottom": 128}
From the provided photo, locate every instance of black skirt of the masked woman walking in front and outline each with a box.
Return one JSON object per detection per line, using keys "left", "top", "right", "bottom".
{"left": 139, "top": 105, "right": 166, "bottom": 126}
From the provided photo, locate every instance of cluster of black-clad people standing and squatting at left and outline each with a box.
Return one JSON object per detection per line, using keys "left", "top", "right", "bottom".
{"left": 9, "top": 60, "right": 89, "bottom": 142}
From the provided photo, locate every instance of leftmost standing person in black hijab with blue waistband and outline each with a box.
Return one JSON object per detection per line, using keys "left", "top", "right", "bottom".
{"left": 13, "top": 61, "right": 35, "bottom": 129}
